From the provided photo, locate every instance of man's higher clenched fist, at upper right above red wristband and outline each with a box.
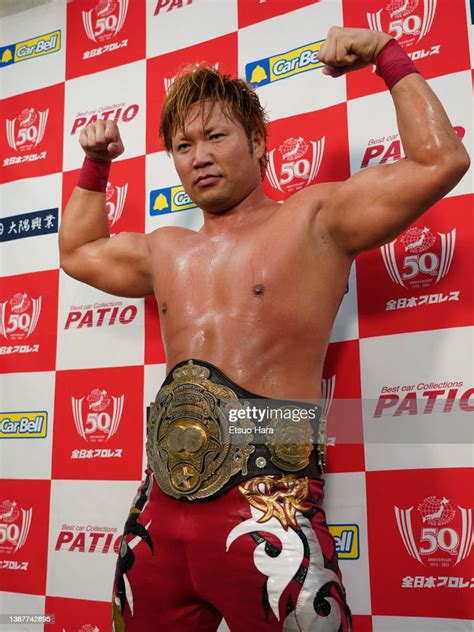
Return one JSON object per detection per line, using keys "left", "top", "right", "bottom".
{"left": 318, "top": 26, "right": 391, "bottom": 77}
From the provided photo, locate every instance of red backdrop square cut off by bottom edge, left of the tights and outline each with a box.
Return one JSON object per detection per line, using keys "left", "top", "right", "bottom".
{"left": 44, "top": 596, "right": 112, "bottom": 632}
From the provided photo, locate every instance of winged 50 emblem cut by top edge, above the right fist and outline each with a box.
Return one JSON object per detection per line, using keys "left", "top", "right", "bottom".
{"left": 367, "top": 0, "right": 438, "bottom": 43}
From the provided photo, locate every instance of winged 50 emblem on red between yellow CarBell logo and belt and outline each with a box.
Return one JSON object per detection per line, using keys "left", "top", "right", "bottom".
{"left": 71, "top": 388, "right": 125, "bottom": 443}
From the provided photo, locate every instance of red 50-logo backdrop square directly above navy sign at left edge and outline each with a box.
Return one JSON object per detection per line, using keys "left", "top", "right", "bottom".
{"left": 0, "top": 83, "right": 64, "bottom": 182}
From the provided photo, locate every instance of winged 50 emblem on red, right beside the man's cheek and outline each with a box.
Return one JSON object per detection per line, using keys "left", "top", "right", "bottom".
{"left": 267, "top": 136, "right": 326, "bottom": 193}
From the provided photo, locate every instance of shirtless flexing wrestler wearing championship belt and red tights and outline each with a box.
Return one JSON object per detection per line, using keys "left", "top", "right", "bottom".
{"left": 59, "top": 27, "right": 469, "bottom": 632}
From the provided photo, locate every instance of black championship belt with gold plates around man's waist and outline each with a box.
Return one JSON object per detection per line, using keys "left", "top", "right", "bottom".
{"left": 146, "top": 360, "right": 324, "bottom": 500}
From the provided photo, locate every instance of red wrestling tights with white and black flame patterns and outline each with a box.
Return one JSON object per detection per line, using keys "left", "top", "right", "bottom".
{"left": 113, "top": 470, "right": 351, "bottom": 632}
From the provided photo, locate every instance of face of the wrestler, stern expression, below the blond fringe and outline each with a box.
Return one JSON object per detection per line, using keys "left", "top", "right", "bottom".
{"left": 172, "top": 101, "right": 264, "bottom": 213}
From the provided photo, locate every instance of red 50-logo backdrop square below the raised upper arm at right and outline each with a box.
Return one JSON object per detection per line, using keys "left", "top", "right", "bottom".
{"left": 356, "top": 195, "right": 474, "bottom": 338}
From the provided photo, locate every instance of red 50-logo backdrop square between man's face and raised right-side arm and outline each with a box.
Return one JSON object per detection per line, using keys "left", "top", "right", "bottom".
{"left": 263, "top": 103, "right": 350, "bottom": 200}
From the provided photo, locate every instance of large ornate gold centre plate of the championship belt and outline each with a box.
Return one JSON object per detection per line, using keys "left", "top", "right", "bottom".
{"left": 146, "top": 362, "right": 255, "bottom": 500}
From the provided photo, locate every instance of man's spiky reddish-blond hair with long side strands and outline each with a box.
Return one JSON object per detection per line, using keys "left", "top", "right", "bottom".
{"left": 160, "top": 64, "right": 267, "bottom": 178}
